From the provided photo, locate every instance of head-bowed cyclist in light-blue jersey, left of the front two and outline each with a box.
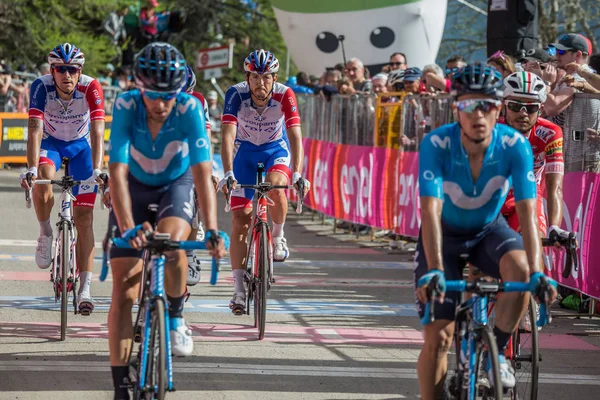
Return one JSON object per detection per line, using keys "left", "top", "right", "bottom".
{"left": 108, "top": 42, "right": 225, "bottom": 399}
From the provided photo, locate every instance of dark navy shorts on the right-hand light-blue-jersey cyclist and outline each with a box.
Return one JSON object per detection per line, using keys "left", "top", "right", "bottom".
{"left": 414, "top": 215, "right": 524, "bottom": 321}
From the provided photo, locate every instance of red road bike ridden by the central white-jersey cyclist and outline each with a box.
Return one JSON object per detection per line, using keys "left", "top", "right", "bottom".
{"left": 226, "top": 163, "right": 304, "bottom": 340}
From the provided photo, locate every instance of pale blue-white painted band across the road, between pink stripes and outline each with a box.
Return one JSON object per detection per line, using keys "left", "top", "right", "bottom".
{"left": 0, "top": 296, "right": 417, "bottom": 317}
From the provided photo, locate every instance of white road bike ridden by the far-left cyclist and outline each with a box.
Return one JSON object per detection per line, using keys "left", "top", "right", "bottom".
{"left": 25, "top": 157, "right": 106, "bottom": 341}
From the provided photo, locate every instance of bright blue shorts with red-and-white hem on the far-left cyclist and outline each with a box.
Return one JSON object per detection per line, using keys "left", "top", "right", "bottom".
{"left": 39, "top": 136, "right": 98, "bottom": 208}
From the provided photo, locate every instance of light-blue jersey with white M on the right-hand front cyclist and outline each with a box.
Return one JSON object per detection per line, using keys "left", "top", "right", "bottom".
{"left": 419, "top": 123, "right": 537, "bottom": 231}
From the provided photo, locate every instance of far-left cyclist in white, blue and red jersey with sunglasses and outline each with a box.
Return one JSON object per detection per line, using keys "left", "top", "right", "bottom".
{"left": 21, "top": 43, "right": 105, "bottom": 315}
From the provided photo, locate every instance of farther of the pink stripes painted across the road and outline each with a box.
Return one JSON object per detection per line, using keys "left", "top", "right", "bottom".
{"left": 0, "top": 270, "right": 414, "bottom": 288}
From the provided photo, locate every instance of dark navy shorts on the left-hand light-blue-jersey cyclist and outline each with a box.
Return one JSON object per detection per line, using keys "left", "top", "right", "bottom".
{"left": 108, "top": 169, "right": 195, "bottom": 258}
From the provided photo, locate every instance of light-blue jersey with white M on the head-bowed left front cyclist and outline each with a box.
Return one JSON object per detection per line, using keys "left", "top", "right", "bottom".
{"left": 110, "top": 90, "right": 211, "bottom": 186}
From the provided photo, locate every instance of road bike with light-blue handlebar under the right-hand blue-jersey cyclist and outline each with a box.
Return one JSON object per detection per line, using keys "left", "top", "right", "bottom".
{"left": 421, "top": 277, "right": 553, "bottom": 400}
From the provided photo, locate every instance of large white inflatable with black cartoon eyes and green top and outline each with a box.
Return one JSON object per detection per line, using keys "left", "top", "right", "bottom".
{"left": 271, "top": 0, "right": 447, "bottom": 76}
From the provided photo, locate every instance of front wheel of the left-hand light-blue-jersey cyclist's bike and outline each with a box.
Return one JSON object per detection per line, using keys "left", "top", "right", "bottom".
{"left": 145, "top": 298, "right": 168, "bottom": 400}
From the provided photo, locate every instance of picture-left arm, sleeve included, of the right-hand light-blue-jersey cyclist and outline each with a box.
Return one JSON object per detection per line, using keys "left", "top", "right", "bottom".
{"left": 419, "top": 133, "right": 449, "bottom": 271}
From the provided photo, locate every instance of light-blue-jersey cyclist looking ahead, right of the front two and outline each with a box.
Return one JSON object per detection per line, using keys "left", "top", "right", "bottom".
{"left": 414, "top": 63, "right": 556, "bottom": 400}
